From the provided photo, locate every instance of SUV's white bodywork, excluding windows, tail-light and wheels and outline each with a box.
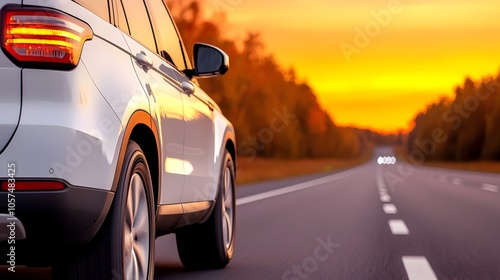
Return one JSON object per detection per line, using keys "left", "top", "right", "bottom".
{"left": 0, "top": 0, "right": 235, "bottom": 257}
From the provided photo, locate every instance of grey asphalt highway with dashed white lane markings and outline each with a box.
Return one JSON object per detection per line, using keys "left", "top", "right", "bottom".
{"left": 0, "top": 149, "right": 500, "bottom": 280}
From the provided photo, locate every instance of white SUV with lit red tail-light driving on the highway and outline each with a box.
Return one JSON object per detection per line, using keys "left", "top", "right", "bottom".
{"left": 0, "top": 0, "right": 236, "bottom": 280}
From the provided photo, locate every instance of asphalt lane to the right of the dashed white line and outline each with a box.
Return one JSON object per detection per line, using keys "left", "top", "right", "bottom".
{"left": 378, "top": 162, "right": 500, "bottom": 279}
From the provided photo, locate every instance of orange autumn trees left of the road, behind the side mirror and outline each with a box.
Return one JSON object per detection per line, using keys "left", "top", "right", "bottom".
{"left": 166, "top": 0, "right": 376, "bottom": 158}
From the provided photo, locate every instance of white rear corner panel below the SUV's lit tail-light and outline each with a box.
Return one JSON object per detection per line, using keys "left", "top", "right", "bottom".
{"left": 0, "top": 65, "right": 121, "bottom": 190}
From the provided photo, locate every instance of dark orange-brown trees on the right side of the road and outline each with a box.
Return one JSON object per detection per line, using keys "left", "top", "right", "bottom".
{"left": 407, "top": 73, "right": 500, "bottom": 161}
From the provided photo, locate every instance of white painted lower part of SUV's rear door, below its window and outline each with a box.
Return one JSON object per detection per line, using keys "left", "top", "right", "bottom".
{"left": 123, "top": 32, "right": 185, "bottom": 204}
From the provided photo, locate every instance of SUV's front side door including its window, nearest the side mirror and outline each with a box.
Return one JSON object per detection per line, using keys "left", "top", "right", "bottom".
{"left": 146, "top": 0, "right": 215, "bottom": 203}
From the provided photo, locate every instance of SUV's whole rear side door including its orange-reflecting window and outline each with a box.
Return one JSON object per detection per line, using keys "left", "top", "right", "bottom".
{"left": 116, "top": 0, "right": 185, "bottom": 205}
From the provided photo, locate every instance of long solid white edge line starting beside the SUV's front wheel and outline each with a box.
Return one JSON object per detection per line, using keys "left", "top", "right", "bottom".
{"left": 236, "top": 166, "right": 362, "bottom": 206}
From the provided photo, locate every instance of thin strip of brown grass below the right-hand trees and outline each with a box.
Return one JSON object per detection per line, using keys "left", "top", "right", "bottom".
{"left": 393, "top": 146, "right": 500, "bottom": 174}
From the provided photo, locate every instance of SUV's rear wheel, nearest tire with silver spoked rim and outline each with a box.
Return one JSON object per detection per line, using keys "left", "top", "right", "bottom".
{"left": 52, "top": 141, "right": 155, "bottom": 280}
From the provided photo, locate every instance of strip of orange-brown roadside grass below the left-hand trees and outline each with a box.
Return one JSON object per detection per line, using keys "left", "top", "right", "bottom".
{"left": 236, "top": 151, "right": 372, "bottom": 186}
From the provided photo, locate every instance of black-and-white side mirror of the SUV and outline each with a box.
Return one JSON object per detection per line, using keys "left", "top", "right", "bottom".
{"left": 194, "top": 43, "right": 229, "bottom": 78}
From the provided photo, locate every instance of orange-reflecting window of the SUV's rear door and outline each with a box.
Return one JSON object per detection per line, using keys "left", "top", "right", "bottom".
{"left": 118, "top": 0, "right": 156, "bottom": 52}
